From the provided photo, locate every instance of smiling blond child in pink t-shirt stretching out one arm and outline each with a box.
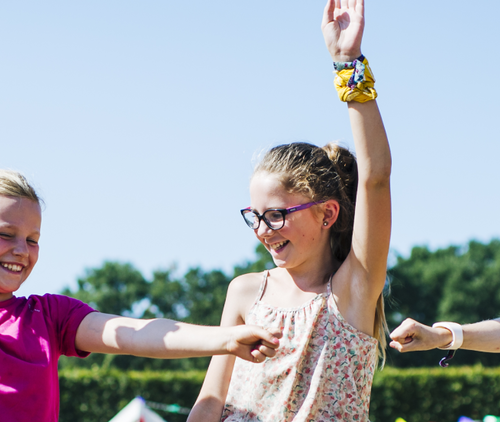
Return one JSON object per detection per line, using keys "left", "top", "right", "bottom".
{"left": 0, "top": 170, "right": 280, "bottom": 422}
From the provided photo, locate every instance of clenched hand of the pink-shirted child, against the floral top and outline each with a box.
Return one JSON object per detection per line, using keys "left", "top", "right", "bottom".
{"left": 227, "top": 325, "right": 282, "bottom": 363}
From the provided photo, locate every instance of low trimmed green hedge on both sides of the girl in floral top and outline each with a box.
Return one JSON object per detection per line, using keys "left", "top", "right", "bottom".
{"left": 60, "top": 366, "right": 500, "bottom": 422}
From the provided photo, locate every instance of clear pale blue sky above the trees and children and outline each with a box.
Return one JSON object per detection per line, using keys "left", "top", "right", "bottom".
{"left": 0, "top": 0, "right": 500, "bottom": 295}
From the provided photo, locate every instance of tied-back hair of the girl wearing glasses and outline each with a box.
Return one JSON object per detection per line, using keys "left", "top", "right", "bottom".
{"left": 254, "top": 142, "right": 389, "bottom": 366}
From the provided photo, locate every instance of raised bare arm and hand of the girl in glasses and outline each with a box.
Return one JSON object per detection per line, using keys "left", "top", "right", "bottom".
{"left": 322, "top": 0, "right": 391, "bottom": 301}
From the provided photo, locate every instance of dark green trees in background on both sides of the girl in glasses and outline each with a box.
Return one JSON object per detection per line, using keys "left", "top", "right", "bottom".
{"left": 60, "top": 239, "right": 500, "bottom": 370}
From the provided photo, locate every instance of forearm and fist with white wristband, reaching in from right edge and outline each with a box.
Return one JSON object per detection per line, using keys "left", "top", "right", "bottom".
{"left": 389, "top": 318, "right": 500, "bottom": 353}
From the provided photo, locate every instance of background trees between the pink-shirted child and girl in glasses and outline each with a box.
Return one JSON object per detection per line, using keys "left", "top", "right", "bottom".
{"left": 59, "top": 262, "right": 230, "bottom": 370}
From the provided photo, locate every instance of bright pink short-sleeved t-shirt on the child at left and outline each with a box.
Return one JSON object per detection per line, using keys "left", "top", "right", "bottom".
{"left": 0, "top": 294, "right": 94, "bottom": 422}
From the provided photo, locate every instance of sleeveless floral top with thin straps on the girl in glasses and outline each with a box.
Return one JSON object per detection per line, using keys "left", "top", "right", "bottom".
{"left": 221, "top": 272, "right": 378, "bottom": 422}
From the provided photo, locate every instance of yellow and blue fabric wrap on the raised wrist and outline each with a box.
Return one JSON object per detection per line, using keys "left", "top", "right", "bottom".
{"left": 333, "top": 55, "right": 377, "bottom": 103}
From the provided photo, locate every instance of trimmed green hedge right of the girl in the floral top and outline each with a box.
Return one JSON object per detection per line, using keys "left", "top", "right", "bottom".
{"left": 370, "top": 366, "right": 500, "bottom": 422}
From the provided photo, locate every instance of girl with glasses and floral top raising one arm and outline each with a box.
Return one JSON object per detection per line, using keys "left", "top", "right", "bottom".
{"left": 188, "top": 0, "right": 391, "bottom": 422}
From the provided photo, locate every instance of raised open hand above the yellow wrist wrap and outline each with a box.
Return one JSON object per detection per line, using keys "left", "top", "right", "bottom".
{"left": 321, "top": 0, "right": 365, "bottom": 62}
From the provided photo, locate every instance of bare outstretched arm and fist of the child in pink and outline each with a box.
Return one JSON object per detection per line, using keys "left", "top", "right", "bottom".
{"left": 75, "top": 312, "right": 279, "bottom": 362}
